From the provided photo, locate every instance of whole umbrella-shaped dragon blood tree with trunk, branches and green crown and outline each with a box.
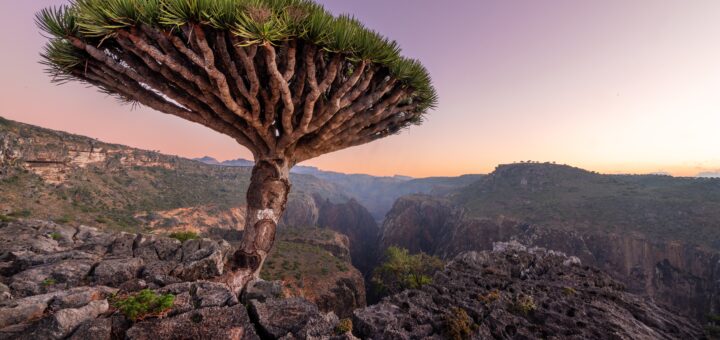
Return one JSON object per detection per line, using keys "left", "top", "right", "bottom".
{"left": 37, "top": 0, "right": 436, "bottom": 284}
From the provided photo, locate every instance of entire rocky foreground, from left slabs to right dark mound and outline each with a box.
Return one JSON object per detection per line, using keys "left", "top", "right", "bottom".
{"left": 0, "top": 221, "right": 703, "bottom": 340}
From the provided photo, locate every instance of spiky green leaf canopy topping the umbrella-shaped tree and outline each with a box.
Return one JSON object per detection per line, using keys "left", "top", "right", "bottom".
{"left": 36, "top": 0, "right": 437, "bottom": 112}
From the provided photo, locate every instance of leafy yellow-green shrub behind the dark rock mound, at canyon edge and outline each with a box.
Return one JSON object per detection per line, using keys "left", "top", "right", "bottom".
{"left": 372, "top": 247, "right": 444, "bottom": 295}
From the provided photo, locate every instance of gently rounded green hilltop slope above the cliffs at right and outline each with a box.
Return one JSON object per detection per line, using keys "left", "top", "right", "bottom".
{"left": 452, "top": 163, "right": 720, "bottom": 249}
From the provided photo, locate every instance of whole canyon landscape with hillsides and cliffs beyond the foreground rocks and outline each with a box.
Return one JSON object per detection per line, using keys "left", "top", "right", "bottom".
{"left": 0, "top": 120, "right": 720, "bottom": 334}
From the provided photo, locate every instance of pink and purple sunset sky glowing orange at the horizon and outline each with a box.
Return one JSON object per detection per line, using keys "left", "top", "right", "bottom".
{"left": 0, "top": 0, "right": 720, "bottom": 177}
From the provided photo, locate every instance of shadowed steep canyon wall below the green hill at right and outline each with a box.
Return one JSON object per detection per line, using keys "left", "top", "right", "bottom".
{"left": 381, "top": 196, "right": 720, "bottom": 320}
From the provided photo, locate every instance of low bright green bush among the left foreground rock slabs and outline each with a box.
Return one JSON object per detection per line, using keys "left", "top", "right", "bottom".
{"left": 111, "top": 289, "right": 175, "bottom": 321}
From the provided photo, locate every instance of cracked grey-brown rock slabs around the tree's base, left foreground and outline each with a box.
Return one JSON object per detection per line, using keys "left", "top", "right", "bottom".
{"left": 0, "top": 221, "right": 360, "bottom": 340}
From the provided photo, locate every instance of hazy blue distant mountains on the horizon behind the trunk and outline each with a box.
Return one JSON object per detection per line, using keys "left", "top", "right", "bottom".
{"left": 198, "top": 157, "right": 482, "bottom": 221}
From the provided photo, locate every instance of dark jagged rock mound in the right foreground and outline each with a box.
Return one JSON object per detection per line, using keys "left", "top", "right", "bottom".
{"left": 353, "top": 244, "right": 703, "bottom": 340}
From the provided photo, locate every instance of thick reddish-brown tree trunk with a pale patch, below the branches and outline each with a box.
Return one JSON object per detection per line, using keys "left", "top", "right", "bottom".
{"left": 236, "top": 159, "right": 290, "bottom": 279}
